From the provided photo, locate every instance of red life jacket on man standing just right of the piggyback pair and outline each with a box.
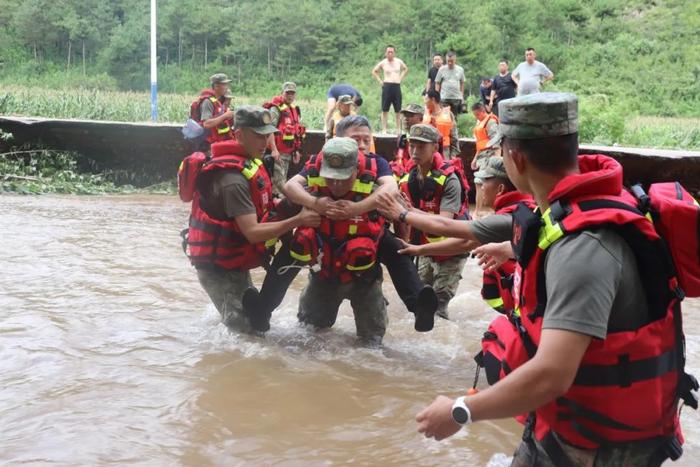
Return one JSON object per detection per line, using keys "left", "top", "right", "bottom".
{"left": 399, "top": 152, "right": 469, "bottom": 261}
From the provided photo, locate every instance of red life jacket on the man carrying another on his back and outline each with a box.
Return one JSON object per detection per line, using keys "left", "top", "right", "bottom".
{"left": 290, "top": 152, "right": 384, "bottom": 283}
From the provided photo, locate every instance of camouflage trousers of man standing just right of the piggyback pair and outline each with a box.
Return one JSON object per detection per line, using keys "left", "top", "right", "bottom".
{"left": 418, "top": 256, "right": 467, "bottom": 319}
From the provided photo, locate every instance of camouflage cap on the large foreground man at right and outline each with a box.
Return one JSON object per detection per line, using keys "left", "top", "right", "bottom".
{"left": 488, "top": 92, "right": 578, "bottom": 147}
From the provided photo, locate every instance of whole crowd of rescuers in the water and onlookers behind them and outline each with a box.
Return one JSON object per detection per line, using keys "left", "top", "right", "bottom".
{"left": 178, "top": 46, "right": 700, "bottom": 466}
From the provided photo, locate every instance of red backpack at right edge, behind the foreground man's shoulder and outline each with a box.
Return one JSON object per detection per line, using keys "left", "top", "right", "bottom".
{"left": 632, "top": 182, "right": 700, "bottom": 297}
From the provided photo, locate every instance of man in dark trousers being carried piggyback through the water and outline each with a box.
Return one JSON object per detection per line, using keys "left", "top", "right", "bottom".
{"left": 245, "top": 115, "right": 438, "bottom": 332}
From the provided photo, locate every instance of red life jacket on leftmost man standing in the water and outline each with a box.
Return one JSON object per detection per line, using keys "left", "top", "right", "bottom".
{"left": 186, "top": 141, "right": 277, "bottom": 270}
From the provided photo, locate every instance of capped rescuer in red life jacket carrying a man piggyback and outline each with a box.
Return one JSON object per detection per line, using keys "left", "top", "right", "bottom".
{"left": 291, "top": 137, "right": 388, "bottom": 345}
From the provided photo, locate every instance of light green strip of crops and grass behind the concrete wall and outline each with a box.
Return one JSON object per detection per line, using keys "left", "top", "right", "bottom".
{"left": 0, "top": 86, "right": 700, "bottom": 150}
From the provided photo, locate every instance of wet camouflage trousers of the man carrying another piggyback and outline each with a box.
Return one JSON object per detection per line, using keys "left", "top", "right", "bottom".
{"left": 297, "top": 269, "right": 389, "bottom": 345}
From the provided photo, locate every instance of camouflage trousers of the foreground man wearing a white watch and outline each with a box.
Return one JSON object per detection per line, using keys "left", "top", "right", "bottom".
{"left": 511, "top": 435, "right": 661, "bottom": 467}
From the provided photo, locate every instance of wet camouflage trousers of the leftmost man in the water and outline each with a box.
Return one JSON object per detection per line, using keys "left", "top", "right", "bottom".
{"left": 197, "top": 268, "right": 253, "bottom": 333}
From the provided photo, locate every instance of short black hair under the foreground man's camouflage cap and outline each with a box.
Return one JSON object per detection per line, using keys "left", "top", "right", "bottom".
{"left": 503, "top": 133, "right": 578, "bottom": 173}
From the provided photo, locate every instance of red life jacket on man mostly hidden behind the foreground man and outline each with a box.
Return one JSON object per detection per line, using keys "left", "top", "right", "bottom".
{"left": 481, "top": 191, "right": 535, "bottom": 315}
